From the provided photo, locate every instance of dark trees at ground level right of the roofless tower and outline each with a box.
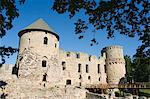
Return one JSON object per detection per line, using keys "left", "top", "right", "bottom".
{"left": 125, "top": 48, "right": 150, "bottom": 82}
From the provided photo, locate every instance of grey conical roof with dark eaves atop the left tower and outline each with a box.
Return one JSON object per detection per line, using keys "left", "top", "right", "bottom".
{"left": 18, "top": 18, "right": 59, "bottom": 39}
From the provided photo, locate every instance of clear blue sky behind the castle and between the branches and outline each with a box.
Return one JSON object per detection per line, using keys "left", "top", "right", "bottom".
{"left": 0, "top": 0, "right": 140, "bottom": 64}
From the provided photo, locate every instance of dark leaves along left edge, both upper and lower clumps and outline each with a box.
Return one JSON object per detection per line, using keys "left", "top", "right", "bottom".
{"left": 0, "top": 0, "right": 24, "bottom": 67}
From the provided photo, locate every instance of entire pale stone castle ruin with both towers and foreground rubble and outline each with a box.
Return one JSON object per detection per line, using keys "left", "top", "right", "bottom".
{"left": 0, "top": 19, "right": 125, "bottom": 99}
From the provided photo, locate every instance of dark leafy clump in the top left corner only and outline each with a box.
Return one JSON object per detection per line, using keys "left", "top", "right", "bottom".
{"left": 0, "top": 0, "right": 19, "bottom": 38}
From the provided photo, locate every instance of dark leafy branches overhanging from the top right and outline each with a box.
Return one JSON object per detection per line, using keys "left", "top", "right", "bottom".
{"left": 52, "top": 0, "right": 150, "bottom": 45}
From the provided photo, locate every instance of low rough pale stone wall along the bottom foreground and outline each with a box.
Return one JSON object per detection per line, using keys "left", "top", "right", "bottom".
{"left": 2, "top": 82, "right": 87, "bottom": 99}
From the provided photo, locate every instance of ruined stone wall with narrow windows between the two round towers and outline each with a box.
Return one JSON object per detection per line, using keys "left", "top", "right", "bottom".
{"left": 59, "top": 50, "right": 106, "bottom": 86}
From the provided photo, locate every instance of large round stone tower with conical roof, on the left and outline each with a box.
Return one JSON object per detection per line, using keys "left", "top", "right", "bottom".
{"left": 17, "top": 19, "right": 61, "bottom": 85}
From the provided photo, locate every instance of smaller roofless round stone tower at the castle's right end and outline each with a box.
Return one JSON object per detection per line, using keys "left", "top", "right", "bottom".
{"left": 105, "top": 46, "right": 126, "bottom": 84}
